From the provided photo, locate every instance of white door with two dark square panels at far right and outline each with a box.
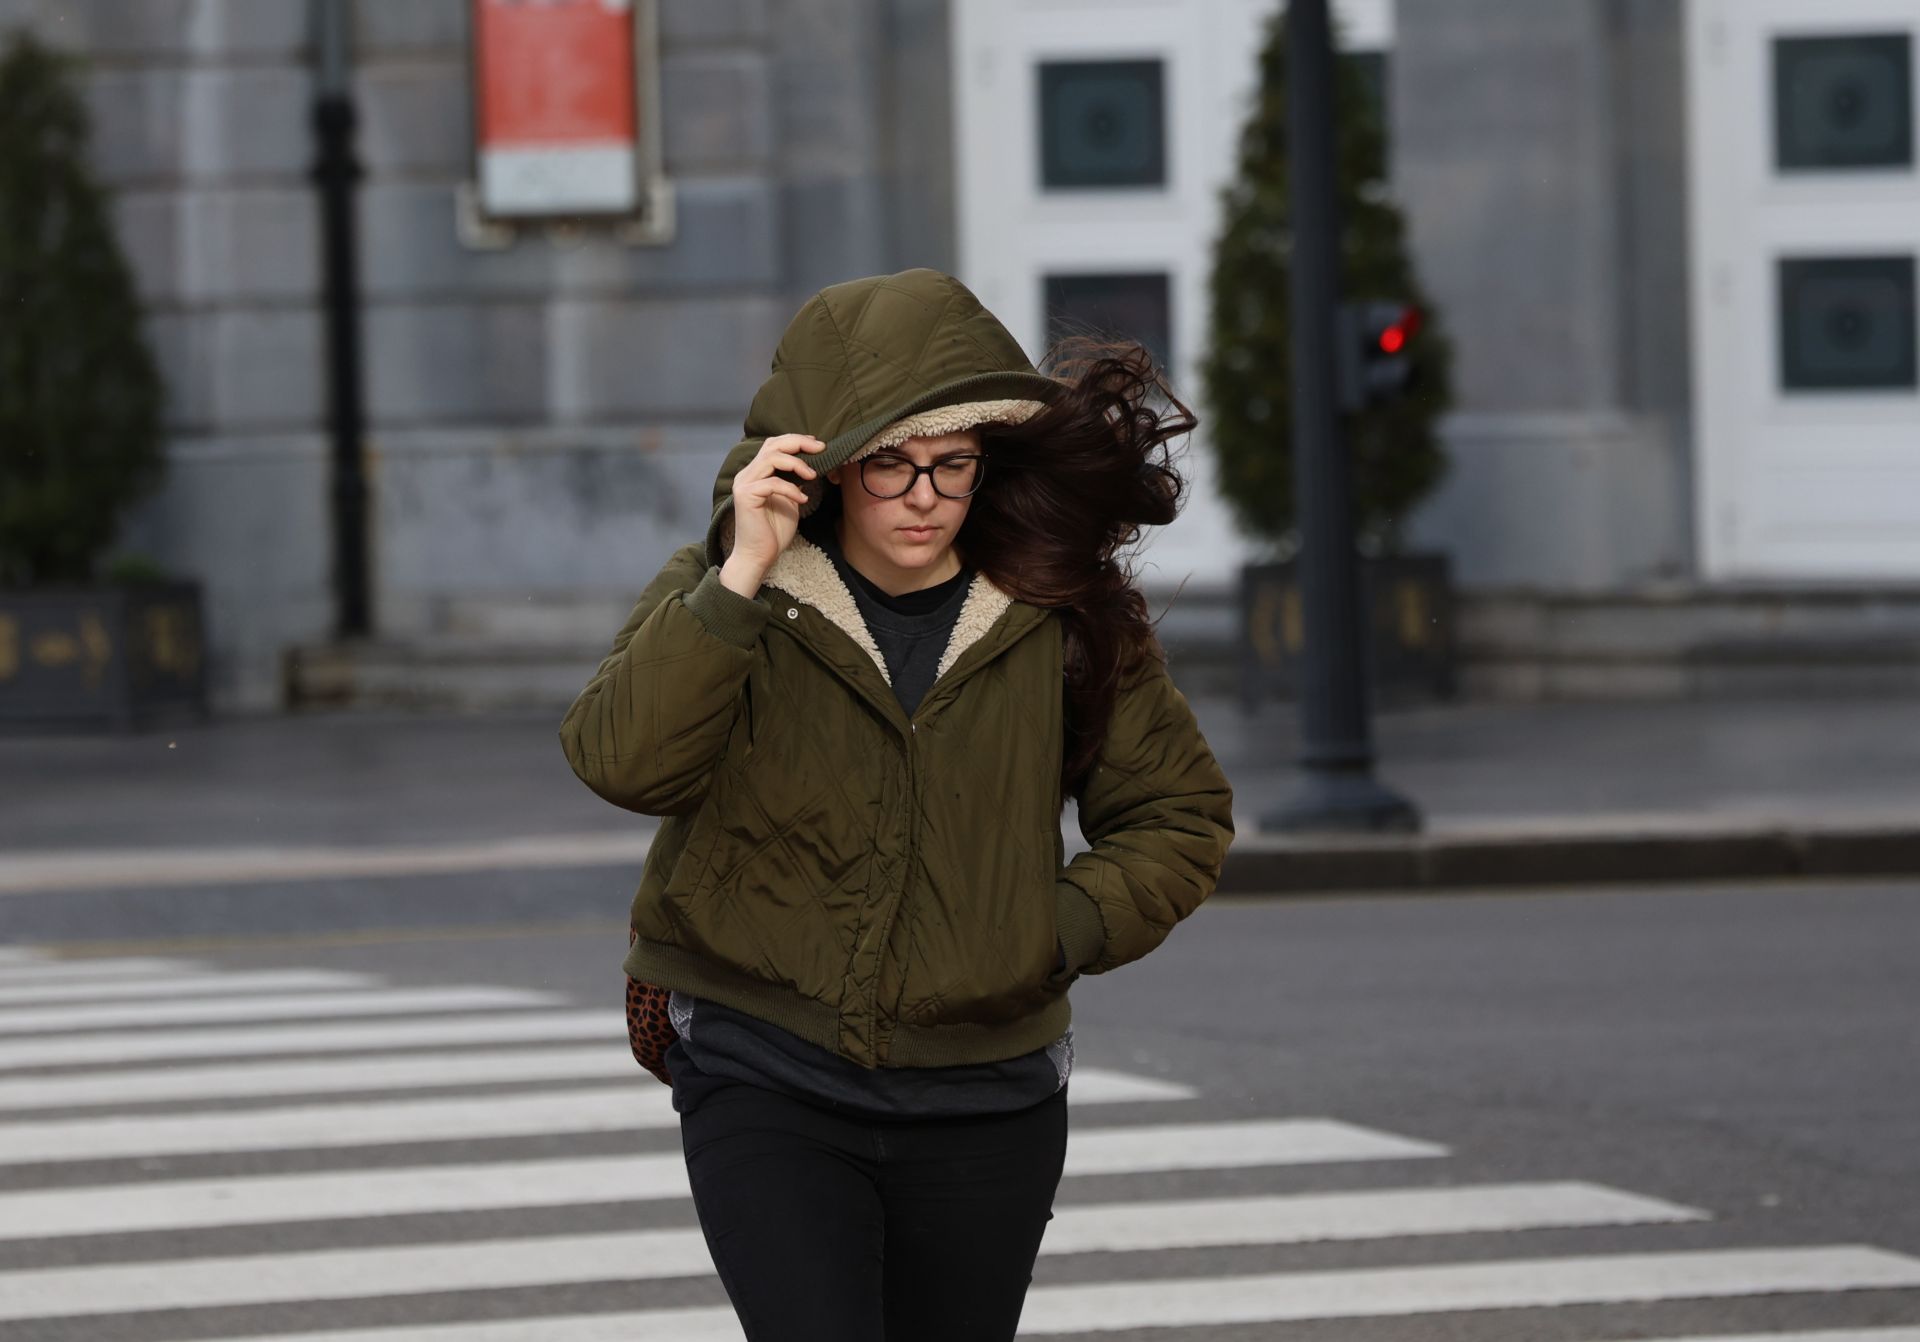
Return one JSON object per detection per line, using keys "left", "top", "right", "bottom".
{"left": 1688, "top": 0, "right": 1920, "bottom": 580}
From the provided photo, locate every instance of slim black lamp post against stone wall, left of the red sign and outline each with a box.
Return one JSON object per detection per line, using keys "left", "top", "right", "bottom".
{"left": 307, "top": 0, "right": 372, "bottom": 637}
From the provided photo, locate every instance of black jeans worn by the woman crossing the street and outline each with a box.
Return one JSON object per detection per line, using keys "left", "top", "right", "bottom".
{"left": 680, "top": 1083, "right": 1068, "bottom": 1342}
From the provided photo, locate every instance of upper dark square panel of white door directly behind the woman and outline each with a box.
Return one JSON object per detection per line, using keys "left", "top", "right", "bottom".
{"left": 1039, "top": 61, "right": 1167, "bottom": 188}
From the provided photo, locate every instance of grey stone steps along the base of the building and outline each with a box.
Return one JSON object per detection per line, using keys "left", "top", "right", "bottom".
{"left": 286, "top": 586, "right": 1920, "bottom": 710}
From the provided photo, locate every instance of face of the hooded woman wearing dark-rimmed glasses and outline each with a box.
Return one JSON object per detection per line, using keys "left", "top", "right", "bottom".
{"left": 828, "top": 428, "right": 981, "bottom": 595}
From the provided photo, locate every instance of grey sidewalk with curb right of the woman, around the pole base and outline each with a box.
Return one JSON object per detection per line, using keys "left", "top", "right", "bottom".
{"left": 1194, "top": 699, "right": 1920, "bottom": 891}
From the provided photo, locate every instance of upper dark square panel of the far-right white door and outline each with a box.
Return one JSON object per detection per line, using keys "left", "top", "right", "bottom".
{"left": 1774, "top": 33, "right": 1914, "bottom": 171}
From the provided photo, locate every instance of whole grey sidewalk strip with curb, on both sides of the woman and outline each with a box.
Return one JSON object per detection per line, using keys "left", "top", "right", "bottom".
{"left": 0, "top": 699, "right": 1920, "bottom": 893}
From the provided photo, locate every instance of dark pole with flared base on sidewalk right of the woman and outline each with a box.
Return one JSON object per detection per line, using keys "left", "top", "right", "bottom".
{"left": 1260, "top": 0, "right": 1419, "bottom": 831}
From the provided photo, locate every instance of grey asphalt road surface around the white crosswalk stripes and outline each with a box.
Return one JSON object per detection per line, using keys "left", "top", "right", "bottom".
{"left": 0, "top": 883, "right": 1920, "bottom": 1342}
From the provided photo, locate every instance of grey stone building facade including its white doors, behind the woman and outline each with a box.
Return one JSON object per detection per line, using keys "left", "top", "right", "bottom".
{"left": 0, "top": 0, "right": 1920, "bottom": 710}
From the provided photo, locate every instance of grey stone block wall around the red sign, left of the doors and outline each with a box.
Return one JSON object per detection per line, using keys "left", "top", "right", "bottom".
{"left": 0, "top": 0, "right": 952, "bottom": 710}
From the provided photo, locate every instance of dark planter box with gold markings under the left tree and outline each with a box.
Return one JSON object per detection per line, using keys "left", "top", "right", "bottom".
{"left": 0, "top": 582, "right": 207, "bottom": 731}
